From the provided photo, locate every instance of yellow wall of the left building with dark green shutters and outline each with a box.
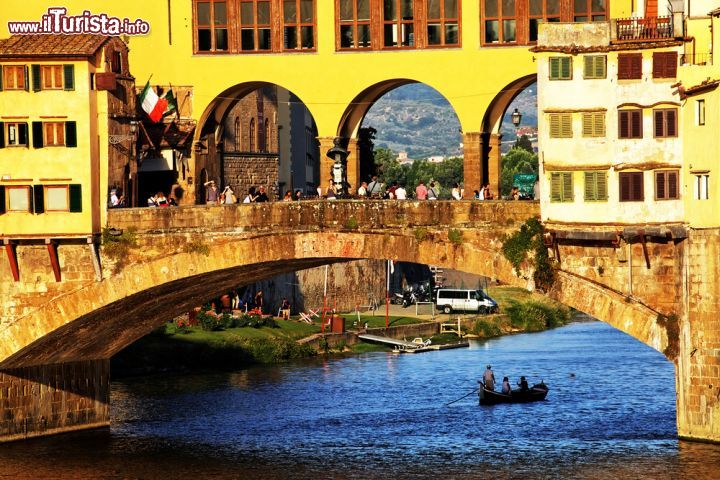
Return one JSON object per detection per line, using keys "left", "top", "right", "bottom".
{"left": 0, "top": 60, "right": 107, "bottom": 236}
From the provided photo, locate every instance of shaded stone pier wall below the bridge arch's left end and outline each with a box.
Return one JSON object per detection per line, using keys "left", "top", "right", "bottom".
{"left": 0, "top": 360, "right": 110, "bottom": 442}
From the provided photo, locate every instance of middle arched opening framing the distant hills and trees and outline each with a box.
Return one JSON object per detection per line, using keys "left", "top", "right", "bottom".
{"left": 338, "top": 79, "right": 463, "bottom": 197}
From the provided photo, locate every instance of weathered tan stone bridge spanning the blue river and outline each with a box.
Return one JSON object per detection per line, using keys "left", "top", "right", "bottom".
{"left": 0, "top": 201, "right": 717, "bottom": 439}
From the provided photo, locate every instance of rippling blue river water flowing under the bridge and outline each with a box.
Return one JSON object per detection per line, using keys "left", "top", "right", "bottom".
{"left": 0, "top": 322, "right": 720, "bottom": 480}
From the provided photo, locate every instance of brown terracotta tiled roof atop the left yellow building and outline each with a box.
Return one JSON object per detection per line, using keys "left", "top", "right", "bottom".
{"left": 0, "top": 34, "right": 111, "bottom": 58}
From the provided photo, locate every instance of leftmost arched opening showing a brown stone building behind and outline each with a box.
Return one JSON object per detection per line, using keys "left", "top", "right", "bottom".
{"left": 195, "top": 82, "right": 320, "bottom": 203}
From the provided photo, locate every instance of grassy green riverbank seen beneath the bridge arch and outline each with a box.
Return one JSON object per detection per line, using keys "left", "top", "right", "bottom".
{"left": 111, "top": 287, "right": 570, "bottom": 377}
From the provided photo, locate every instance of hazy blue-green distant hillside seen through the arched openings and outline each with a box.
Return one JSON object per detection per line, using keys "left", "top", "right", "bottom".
{"left": 362, "top": 83, "right": 537, "bottom": 159}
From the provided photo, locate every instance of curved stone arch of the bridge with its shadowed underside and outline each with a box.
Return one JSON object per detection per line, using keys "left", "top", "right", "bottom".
{"left": 0, "top": 230, "right": 668, "bottom": 368}
